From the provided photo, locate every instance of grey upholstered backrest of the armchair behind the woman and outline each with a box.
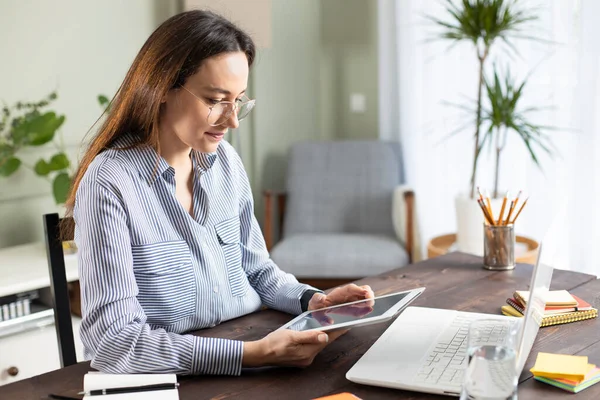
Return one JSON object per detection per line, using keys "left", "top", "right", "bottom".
{"left": 283, "top": 141, "right": 402, "bottom": 237}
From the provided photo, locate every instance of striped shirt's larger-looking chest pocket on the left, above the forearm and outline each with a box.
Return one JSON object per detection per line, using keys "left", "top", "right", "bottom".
{"left": 132, "top": 241, "right": 196, "bottom": 326}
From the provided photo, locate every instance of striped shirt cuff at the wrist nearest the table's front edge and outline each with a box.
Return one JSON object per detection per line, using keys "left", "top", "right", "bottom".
{"left": 192, "top": 337, "right": 244, "bottom": 375}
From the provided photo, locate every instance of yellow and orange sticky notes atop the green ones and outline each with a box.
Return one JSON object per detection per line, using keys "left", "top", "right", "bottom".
{"left": 530, "top": 353, "right": 590, "bottom": 382}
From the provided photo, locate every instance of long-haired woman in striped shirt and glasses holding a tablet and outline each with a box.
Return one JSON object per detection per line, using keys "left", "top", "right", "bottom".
{"left": 67, "top": 11, "right": 373, "bottom": 375}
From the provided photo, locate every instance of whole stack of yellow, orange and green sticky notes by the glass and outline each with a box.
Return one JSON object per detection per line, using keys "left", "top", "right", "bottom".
{"left": 530, "top": 353, "right": 600, "bottom": 393}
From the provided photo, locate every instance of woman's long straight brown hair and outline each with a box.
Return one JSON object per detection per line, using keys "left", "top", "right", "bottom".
{"left": 61, "top": 10, "right": 256, "bottom": 237}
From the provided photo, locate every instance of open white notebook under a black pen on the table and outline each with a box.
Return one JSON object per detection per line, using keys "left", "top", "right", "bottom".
{"left": 83, "top": 372, "right": 179, "bottom": 400}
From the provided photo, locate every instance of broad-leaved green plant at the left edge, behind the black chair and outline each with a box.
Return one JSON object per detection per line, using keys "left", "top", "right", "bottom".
{"left": 0, "top": 92, "right": 72, "bottom": 204}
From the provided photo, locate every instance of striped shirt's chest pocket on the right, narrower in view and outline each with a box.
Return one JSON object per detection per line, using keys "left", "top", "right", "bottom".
{"left": 215, "top": 217, "right": 250, "bottom": 296}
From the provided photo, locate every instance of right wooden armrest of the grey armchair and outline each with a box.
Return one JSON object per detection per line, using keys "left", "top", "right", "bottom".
{"left": 392, "top": 186, "right": 422, "bottom": 262}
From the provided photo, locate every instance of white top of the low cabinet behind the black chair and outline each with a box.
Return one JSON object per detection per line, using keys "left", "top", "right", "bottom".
{"left": 0, "top": 242, "right": 79, "bottom": 297}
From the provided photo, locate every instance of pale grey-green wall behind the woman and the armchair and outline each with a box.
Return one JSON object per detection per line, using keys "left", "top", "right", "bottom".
{"left": 0, "top": 0, "right": 377, "bottom": 248}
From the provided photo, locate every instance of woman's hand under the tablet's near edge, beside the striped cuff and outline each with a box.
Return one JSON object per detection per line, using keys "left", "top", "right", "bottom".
{"left": 242, "top": 329, "right": 345, "bottom": 367}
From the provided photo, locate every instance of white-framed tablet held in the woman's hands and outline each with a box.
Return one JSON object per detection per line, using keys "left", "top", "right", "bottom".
{"left": 279, "top": 287, "right": 425, "bottom": 331}
